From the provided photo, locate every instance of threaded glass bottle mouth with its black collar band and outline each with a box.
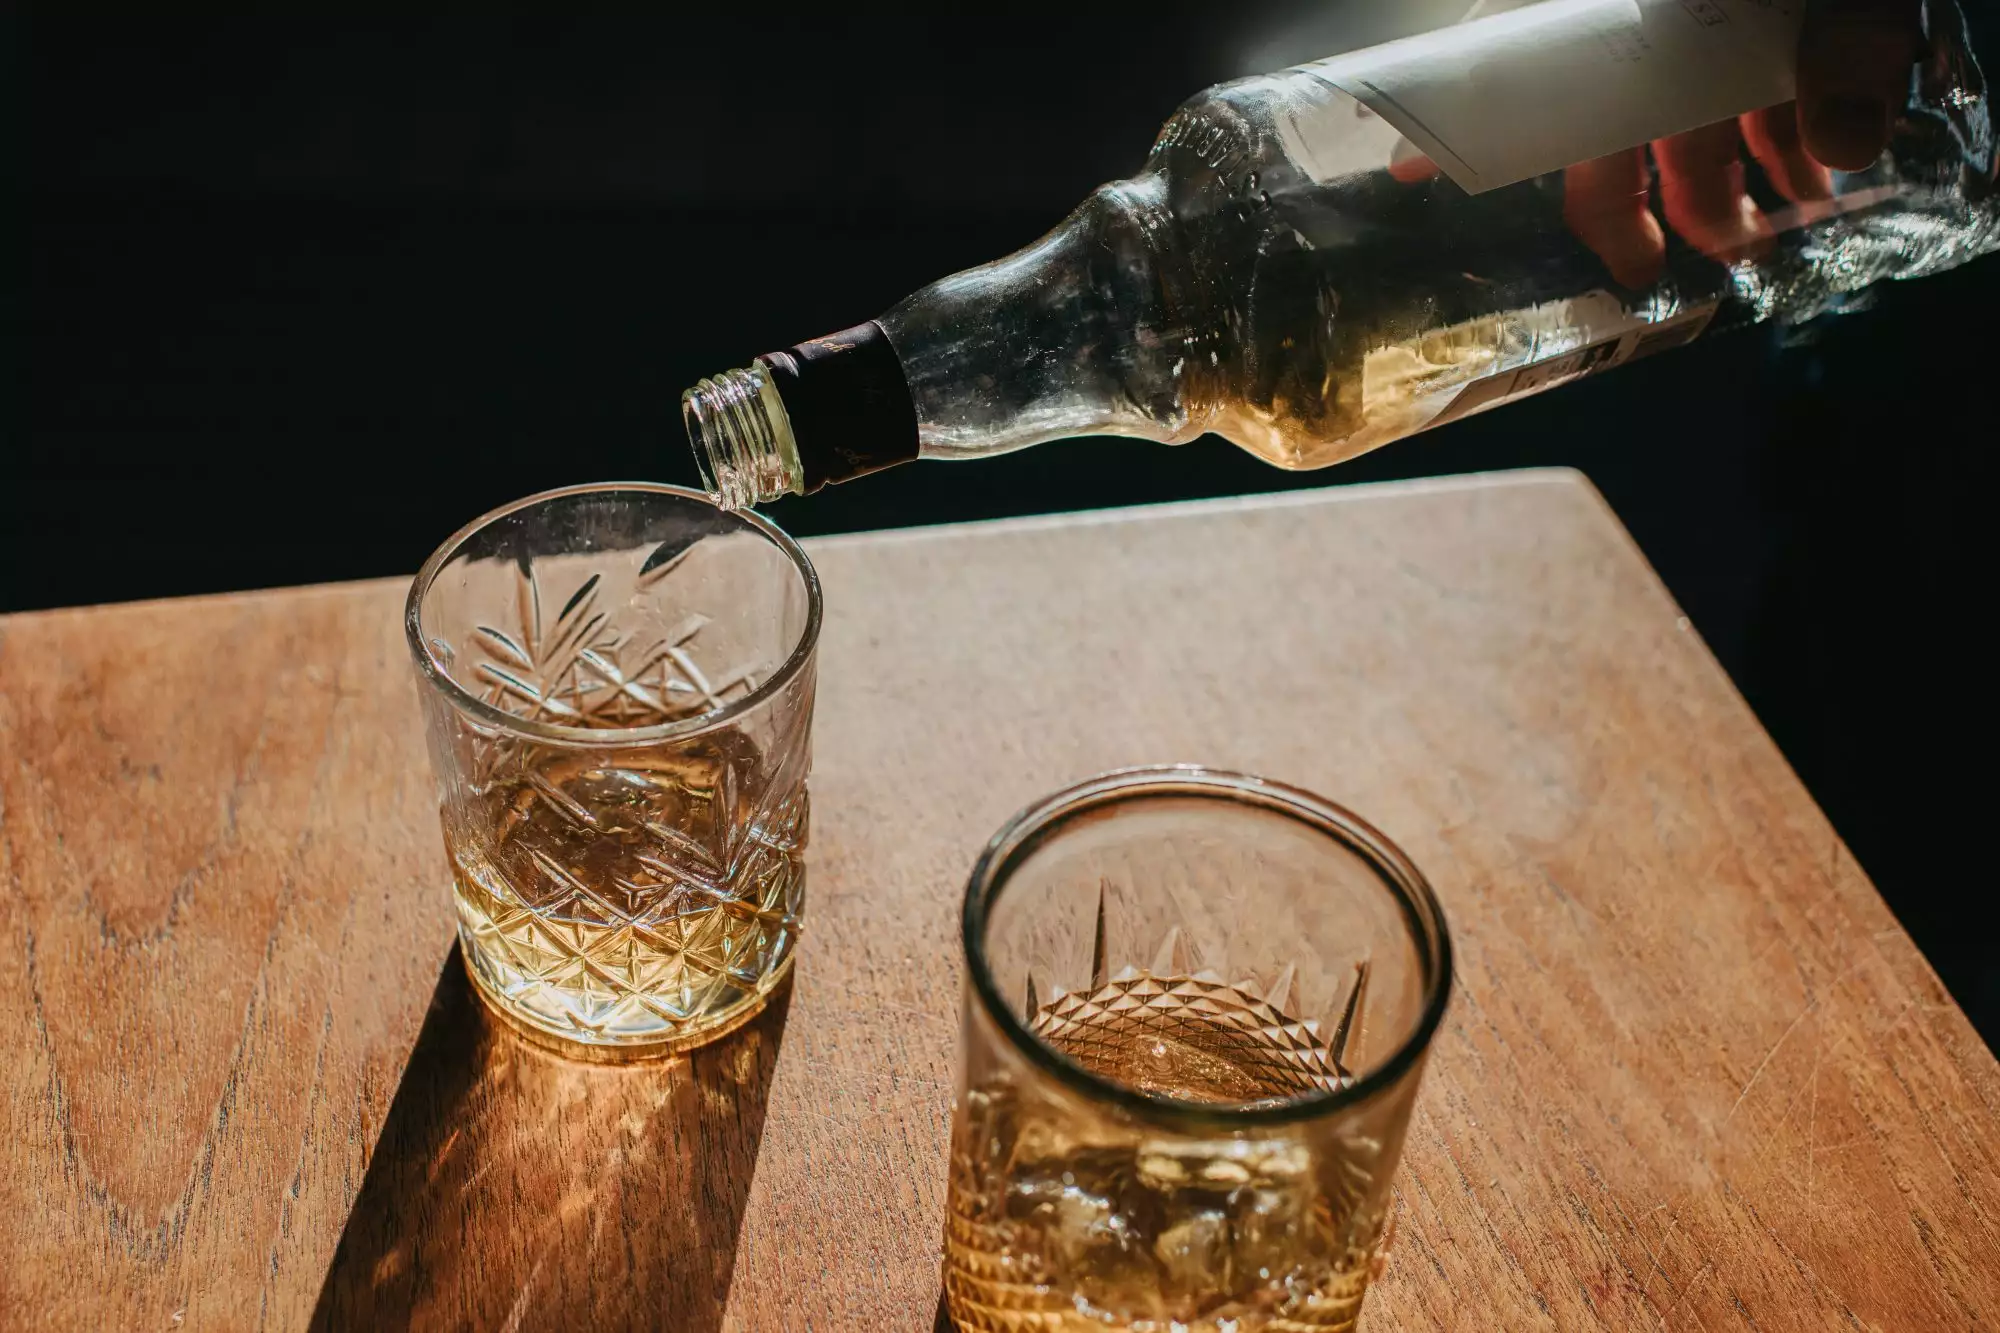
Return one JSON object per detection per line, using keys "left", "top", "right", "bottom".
{"left": 680, "top": 322, "right": 918, "bottom": 508}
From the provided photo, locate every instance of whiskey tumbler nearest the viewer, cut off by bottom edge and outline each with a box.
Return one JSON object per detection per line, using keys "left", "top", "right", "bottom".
{"left": 944, "top": 767, "right": 1452, "bottom": 1333}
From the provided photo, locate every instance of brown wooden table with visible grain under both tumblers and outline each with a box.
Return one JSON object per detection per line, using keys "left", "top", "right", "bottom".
{"left": 0, "top": 472, "right": 2000, "bottom": 1333}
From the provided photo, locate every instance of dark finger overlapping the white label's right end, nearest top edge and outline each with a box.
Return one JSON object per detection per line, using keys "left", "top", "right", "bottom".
{"left": 1798, "top": 0, "right": 1922, "bottom": 172}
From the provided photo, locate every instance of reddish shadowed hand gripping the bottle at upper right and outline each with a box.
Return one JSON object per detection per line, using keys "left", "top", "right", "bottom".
{"left": 1562, "top": 0, "right": 1922, "bottom": 286}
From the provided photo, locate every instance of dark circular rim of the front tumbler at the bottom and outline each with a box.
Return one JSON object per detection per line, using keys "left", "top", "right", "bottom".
{"left": 960, "top": 765, "right": 1452, "bottom": 1129}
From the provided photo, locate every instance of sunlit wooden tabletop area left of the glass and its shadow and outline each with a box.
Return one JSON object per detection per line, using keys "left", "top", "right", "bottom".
{"left": 0, "top": 584, "right": 452, "bottom": 1329}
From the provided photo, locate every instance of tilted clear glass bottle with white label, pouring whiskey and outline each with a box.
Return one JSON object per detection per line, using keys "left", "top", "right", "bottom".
{"left": 682, "top": 0, "right": 2000, "bottom": 506}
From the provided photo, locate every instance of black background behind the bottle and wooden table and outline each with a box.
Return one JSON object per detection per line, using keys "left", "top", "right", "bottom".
{"left": 19, "top": 0, "right": 2000, "bottom": 1041}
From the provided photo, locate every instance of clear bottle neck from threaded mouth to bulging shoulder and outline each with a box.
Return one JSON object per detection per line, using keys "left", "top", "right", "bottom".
{"left": 682, "top": 174, "right": 1192, "bottom": 508}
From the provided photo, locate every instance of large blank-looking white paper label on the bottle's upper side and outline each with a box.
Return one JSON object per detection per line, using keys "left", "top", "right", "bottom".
{"left": 1294, "top": 0, "right": 1804, "bottom": 194}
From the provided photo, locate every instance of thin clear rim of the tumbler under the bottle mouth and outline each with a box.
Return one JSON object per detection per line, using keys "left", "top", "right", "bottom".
{"left": 402, "top": 480, "right": 824, "bottom": 747}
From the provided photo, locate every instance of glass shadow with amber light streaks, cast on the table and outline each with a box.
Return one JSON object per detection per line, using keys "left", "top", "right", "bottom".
{"left": 312, "top": 947, "right": 792, "bottom": 1333}
